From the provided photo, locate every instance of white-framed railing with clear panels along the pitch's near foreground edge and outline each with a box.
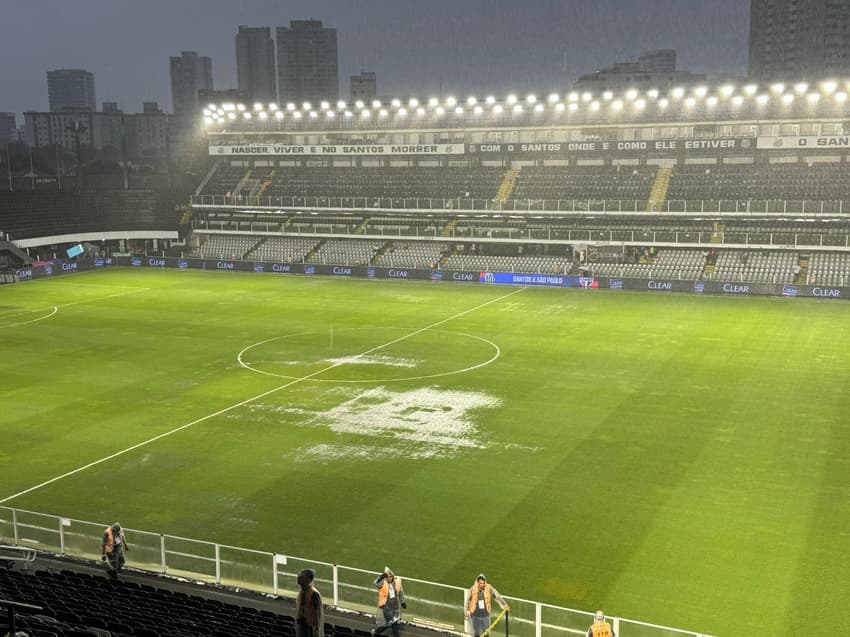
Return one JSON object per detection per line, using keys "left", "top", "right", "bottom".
{"left": 0, "top": 507, "right": 709, "bottom": 637}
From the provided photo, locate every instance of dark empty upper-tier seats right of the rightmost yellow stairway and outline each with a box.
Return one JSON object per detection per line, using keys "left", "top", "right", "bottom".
{"left": 667, "top": 164, "right": 850, "bottom": 201}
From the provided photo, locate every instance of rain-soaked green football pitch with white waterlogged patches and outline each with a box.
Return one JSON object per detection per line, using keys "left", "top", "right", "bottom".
{"left": 0, "top": 270, "right": 850, "bottom": 637}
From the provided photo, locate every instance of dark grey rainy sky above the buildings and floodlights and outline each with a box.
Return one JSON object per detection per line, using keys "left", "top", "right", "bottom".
{"left": 0, "top": 0, "right": 750, "bottom": 118}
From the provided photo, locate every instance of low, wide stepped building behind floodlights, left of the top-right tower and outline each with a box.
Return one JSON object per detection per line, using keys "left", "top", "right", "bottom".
{"left": 574, "top": 49, "right": 706, "bottom": 93}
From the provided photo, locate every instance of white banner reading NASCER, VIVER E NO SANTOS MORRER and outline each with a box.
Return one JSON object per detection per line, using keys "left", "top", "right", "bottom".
{"left": 210, "top": 144, "right": 466, "bottom": 157}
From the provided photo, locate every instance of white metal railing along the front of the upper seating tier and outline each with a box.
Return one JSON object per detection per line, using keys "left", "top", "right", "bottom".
{"left": 191, "top": 195, "right": 850, "bottom": 217}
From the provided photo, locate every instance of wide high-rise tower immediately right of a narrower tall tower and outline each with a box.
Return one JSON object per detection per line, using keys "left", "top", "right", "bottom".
{"left": 276, "top": 20, "right": 339, "bottom": 103}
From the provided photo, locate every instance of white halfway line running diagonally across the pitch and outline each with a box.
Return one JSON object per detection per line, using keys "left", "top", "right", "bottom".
{"left": 0, "top": 288, "right": 527, "bottom": 504}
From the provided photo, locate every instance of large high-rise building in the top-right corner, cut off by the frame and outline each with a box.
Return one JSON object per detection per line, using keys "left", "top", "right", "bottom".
{"left": 749, "top": 0, "right": 850, "bottom": 81}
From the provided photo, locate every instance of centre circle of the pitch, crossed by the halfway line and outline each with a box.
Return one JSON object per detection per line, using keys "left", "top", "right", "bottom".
{"left": 236, "top": 327, "right": 501, "bottom": 383}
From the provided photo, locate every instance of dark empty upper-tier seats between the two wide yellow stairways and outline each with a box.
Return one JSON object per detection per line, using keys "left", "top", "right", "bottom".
{"left": 512, "top": 166, "right": 656, "bottom": 202}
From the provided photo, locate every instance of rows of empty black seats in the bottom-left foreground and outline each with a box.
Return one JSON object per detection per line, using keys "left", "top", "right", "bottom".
{"left": 0, "top": 570, "right": 306, "bottom": 637}
